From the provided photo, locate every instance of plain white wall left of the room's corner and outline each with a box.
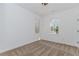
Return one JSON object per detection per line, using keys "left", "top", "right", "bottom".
{"left": 0, "top": 4, "right": 40, "bottom": 52}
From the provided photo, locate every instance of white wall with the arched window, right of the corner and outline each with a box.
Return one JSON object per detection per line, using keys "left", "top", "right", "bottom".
{"left": 41, "top": 8, "right": 79, "bottom": 47}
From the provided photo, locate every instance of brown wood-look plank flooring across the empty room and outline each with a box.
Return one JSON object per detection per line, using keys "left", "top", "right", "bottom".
{"left": 0, "top": 40, "right": 79, "bottom": 56}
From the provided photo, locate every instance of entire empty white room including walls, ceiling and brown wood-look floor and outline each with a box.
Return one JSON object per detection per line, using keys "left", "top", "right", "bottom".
{"left": 0, "top": 3, "right": 79, "bottom": 56}
